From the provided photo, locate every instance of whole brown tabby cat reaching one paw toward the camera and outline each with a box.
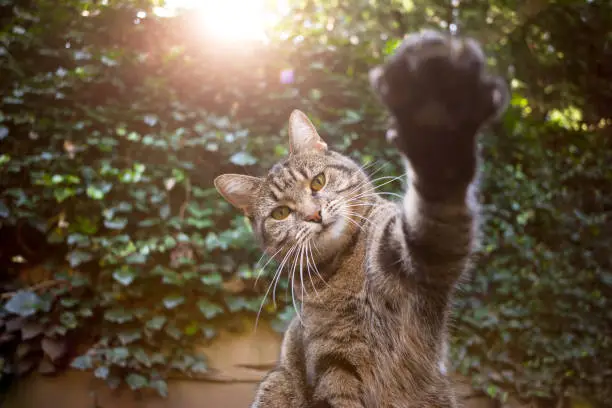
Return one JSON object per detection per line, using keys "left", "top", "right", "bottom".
{"left": 215, "top": 31, "right": 509, "bottom": 408}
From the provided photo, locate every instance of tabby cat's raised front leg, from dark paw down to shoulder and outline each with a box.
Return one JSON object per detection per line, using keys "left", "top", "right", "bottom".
{"left": 370, "top": 31, "right": 508, "bottom": 294}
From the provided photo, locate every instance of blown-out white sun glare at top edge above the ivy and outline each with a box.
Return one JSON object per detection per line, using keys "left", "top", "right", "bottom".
{"left": 154, "top": 0, "right": 278, "bottom": 42}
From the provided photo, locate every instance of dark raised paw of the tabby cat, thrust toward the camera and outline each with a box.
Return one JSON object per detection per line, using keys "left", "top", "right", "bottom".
{"left": 370, "top": 31, "right": 508, "bottom": 134}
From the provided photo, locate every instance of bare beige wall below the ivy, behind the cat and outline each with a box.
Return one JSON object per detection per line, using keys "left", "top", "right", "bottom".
{"left": 2, "top": 326, "right": 572, "bottom": 408}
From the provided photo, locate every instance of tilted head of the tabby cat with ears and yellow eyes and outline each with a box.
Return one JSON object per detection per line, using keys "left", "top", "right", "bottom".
{"left": 215, "top": 111, "right": 372, "bottom": 267}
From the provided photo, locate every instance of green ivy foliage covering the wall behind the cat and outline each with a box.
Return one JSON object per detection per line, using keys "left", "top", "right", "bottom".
{"left": 0, "top": 0, "right": 612, "bottom": 406}
